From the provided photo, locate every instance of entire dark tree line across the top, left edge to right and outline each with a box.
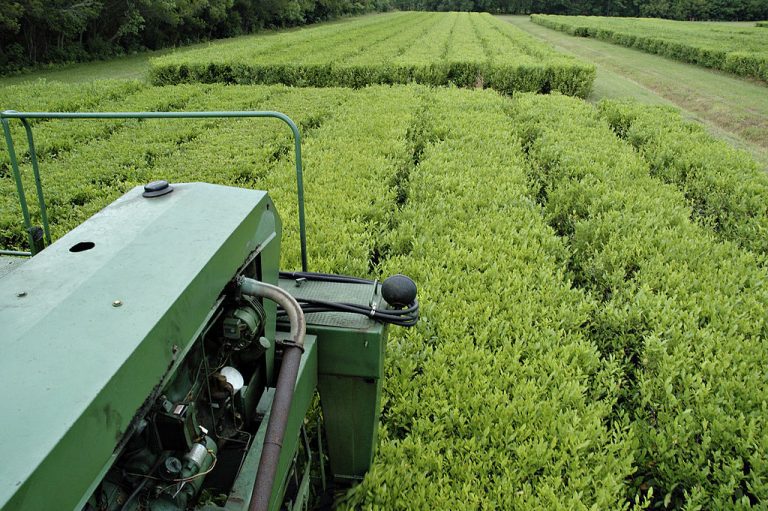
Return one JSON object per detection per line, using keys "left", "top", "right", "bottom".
{"left": 0, "top": 0, "right": 768, "bottom": 73}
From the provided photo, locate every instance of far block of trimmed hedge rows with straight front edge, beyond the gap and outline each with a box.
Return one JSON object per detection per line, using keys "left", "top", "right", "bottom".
{"left": 150, "top": 12, "right": 595, "bottom": 97}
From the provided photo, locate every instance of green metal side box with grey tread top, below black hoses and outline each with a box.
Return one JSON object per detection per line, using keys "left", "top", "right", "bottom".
{"left": 280, "top": 279, "right": 386, "bottom": 481}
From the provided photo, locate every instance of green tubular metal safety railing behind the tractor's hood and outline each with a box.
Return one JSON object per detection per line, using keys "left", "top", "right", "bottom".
{"left": 0, "top": 110, "right": 307, "bottom": 271}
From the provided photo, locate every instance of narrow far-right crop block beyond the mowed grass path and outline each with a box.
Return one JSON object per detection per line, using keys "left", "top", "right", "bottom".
{"left": 531, "top": 14, "right": 768, "bottom": 81}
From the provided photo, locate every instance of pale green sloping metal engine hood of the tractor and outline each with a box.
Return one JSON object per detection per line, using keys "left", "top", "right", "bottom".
{"left": 0, "top": 184, "right": 280, "bottom": 511}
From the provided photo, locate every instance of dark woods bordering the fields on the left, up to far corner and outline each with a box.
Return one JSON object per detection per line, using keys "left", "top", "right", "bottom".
{"left": 0, "top": 0, "right": 390, "bottom": 73}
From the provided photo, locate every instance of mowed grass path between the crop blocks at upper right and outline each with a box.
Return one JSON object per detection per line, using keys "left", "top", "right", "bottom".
{"left": 503, "top": 16, "right": 768, "bottom": 168}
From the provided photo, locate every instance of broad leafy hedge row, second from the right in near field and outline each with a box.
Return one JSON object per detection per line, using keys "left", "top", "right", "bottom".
{"left": 511, "top": 92, "right": 768, "bottom": 509}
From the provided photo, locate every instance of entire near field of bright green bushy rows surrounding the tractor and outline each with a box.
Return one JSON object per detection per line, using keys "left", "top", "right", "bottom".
{"left": 0, "top": 76, "right": 768, "bottom": 509}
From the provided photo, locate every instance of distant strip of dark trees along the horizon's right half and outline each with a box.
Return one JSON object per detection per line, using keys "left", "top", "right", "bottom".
{"left": 394, "top": 0, "right": 768, "bottom": 21}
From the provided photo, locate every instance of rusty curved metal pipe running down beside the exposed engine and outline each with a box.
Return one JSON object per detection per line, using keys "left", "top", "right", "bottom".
{"left": 238, "top": 277, "right": 307, "bottom": 511}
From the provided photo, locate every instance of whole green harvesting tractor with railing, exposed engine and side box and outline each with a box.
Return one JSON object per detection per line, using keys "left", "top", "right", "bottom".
{"left": 0, "top": 112, "right": 418, "bottom": 511}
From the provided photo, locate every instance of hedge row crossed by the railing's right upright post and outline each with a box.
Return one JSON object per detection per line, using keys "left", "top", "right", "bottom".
{"left": 262, "top": 87, "right": 423, "bottom": 275}
